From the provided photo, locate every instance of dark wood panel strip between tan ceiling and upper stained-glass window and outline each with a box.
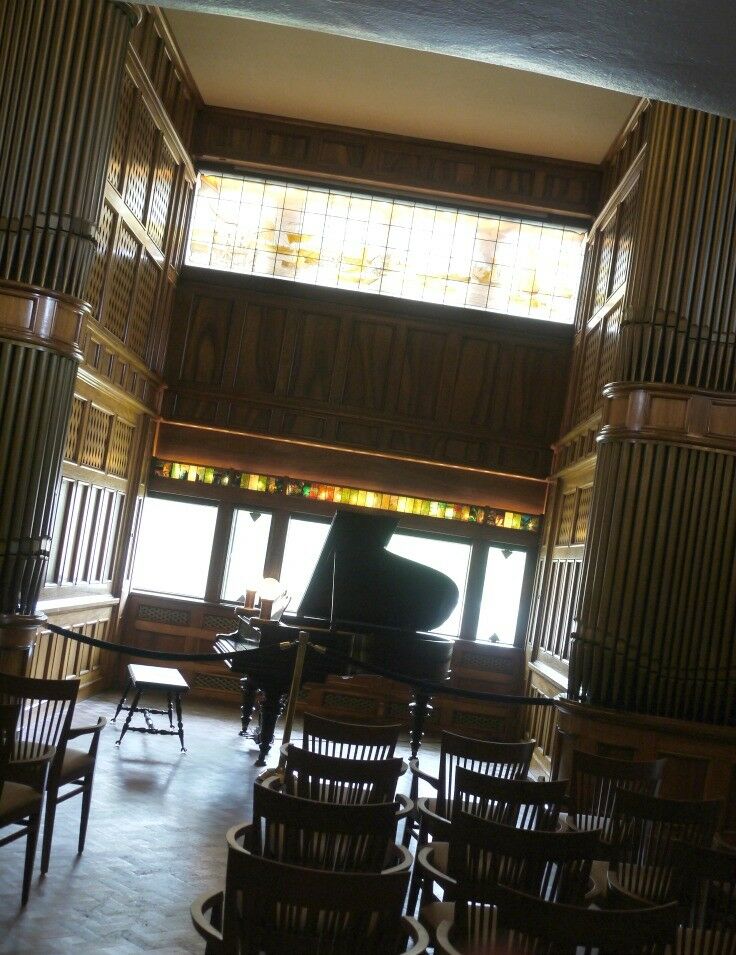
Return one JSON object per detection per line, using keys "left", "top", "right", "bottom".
{"left": 192, "top": 107, "right": 601, "bottom": 223}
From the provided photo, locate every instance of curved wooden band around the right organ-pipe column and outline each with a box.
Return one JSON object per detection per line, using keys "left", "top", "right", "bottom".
{"left": 597, "top": 382, "right": 736, "bottom": 454}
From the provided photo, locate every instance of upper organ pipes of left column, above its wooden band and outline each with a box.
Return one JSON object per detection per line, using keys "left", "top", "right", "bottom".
{"left": 0, "top": 2, "right": 133, "bottom": 298}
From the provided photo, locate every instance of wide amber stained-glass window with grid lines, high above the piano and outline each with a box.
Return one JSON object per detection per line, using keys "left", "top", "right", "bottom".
{"left": 187, "top": 173, "right": 585, "bottom": 323}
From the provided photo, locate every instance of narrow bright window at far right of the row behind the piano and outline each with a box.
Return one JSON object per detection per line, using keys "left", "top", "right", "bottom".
{"left": 476, "top": 547, "right": 526, "bottom": 644}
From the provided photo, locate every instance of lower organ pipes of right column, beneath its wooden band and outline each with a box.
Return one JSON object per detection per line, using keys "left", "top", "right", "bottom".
{"left": 570, "top": 442, "right": 736, "bottom": 723}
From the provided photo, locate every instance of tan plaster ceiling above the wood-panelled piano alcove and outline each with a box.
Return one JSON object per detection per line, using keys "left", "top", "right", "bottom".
{"left": 167, "top": 10, "right": 636, "bottom": 163}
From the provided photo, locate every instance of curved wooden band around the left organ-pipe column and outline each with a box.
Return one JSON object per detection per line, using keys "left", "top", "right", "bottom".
{"left": 0, "top": 280, "right": 90, "bottom": 361}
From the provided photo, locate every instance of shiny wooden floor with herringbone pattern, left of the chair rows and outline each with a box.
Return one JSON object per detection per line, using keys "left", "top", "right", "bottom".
{"left": 0, "top": 695, "right": 437, "bottom": 955}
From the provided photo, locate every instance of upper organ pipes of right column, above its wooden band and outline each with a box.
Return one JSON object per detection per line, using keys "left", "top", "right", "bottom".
{"left": 617, "top": 107, "right": 736, "bottom": 392}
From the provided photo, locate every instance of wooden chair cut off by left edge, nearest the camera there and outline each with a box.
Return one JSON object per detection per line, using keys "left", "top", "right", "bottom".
{"left": 0, "top": 703, "right": 55, "bottom": 905}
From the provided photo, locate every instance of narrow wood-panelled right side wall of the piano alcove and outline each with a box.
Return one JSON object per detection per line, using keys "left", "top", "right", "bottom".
{"left": 528, "top": 101, "right": 649, "bottom": 771}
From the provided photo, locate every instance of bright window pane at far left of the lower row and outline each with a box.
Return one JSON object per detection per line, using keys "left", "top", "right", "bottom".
{"left": 133, "top": 497, "right": 217, "bottom": 598}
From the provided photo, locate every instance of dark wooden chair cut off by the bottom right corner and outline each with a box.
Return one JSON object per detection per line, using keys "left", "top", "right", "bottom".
{"left": 672, "top": 842, "right": 736, "bottom": 955}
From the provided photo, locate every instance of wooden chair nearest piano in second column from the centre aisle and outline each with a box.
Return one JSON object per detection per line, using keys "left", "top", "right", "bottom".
{"left": 404, "top": 733, "right": 535, "bottom": 912}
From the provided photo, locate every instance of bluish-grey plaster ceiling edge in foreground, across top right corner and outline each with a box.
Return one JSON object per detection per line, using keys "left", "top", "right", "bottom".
{"left": 155, "top": 0, "right": 736, "bottom": 122}
